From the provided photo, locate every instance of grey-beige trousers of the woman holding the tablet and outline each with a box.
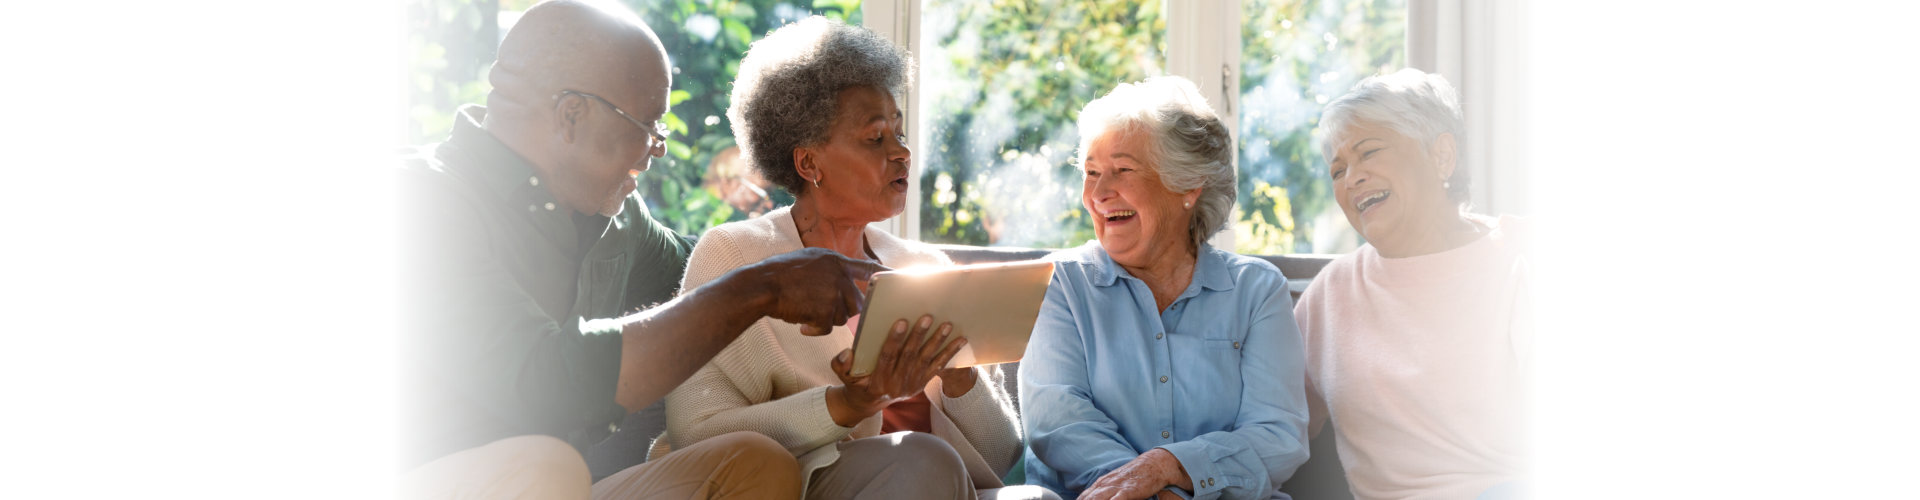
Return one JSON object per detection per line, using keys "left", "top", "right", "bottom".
{"left": 802, "top": 433, "right": 1060, "bottom": 500}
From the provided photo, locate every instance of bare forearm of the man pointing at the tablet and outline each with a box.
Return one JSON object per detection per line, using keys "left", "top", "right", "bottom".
{"left": 614, "top": 271, "right": 768, "bottom": 410}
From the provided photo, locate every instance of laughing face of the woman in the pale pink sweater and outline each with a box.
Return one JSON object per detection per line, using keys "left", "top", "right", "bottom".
{"left": 1327, "top": 121, "right": 1457, "bottom": 254}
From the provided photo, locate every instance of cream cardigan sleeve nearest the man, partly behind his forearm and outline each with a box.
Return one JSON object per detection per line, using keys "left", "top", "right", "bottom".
{"left": 666, "top": 229, "right": 852, "bottom": 456}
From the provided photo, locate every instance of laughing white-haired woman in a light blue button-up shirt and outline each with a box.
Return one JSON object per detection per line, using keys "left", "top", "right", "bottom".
{"left": 1020, "top": 77, "right": 1308, "bottom": 500}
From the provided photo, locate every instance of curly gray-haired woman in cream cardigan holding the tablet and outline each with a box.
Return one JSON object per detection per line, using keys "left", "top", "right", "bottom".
{"left": 666, "top": 17, "right": 1054, "bottom": 498}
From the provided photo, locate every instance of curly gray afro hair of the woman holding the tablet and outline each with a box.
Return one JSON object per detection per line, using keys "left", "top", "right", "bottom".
{"left": 726, "top": 15, "right": 914, "bottom": 194}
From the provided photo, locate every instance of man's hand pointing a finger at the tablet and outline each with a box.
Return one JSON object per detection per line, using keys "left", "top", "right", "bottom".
{"left": 735, "top": 248, "right": 887, "bottom": 337}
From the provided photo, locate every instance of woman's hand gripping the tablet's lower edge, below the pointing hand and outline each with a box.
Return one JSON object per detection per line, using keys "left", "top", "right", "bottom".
{"left": 833, "top": 315, "right": 966, "bottom": 417}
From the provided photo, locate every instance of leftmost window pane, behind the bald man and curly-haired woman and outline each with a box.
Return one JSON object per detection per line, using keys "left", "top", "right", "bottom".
{"left": 409, "top": 0, "right": 860, "bottom": 235}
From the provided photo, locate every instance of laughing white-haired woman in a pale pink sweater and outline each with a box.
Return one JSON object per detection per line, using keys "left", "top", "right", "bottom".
{"left": 1294, "top": 69, "right": 1526, "bottom": 498}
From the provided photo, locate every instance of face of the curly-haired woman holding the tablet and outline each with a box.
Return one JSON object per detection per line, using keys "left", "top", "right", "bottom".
{"left": 795, "top": 87, "right": 912, "bottom": 223}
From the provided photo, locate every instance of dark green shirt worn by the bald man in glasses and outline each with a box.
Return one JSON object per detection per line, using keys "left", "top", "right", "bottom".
{"left": 396, "top": 106, "right": 691, "bottom": 467}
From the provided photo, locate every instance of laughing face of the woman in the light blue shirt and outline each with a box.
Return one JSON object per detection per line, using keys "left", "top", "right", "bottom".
{"left": 1081, "top": 129, "right": 1200, "bottom": 267}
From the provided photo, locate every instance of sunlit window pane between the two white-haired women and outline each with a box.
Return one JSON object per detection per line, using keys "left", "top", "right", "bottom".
{"left": 1235, "top": 0, "right": 1407, "bottom": 254}
